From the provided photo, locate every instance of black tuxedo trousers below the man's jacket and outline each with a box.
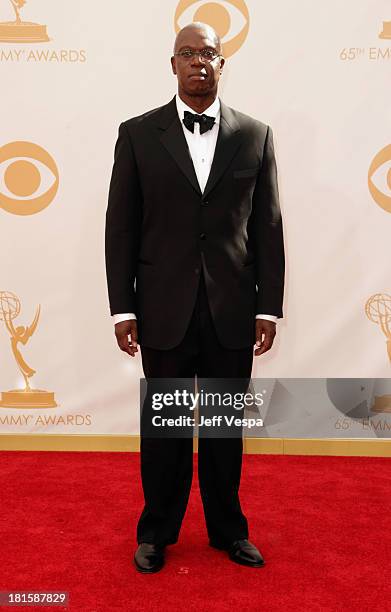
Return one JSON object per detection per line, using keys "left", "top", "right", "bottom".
{"left": 137, "top": 268, "right": 255, "bottom": 546}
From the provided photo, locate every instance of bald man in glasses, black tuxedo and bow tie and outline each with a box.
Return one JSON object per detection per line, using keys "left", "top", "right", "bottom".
{"left": 106, "top": 23, "right": 284, "bottom": 573}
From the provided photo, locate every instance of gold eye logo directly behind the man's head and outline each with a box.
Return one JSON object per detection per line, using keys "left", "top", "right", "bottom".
{"left": 174, "top": 0, "right": 250, "bottom": 57}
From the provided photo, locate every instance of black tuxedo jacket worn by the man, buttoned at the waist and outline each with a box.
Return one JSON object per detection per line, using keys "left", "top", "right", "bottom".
{"left": 105, "top": 97, "right": 284, "bottom": 349}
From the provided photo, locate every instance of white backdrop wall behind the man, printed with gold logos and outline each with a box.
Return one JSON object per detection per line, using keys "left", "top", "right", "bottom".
{"left": 0, "top": 0, "right": 391, "bottom": 434}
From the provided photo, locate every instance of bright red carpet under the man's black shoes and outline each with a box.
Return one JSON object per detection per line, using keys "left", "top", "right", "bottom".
{"left": 0, "top": 452, "right": 391, "bottom": 612}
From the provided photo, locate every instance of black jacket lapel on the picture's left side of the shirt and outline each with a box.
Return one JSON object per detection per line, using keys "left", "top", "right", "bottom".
{"left": 159, "top": 97, "right": 201, "bottom": 195}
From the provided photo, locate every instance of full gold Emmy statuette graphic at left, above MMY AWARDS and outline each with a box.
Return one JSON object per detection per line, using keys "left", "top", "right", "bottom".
{"left": 0, "top": 291, "right": 57, "bottom": 408}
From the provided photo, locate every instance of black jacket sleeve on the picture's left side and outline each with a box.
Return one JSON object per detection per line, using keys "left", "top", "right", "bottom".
{"left": 105, "top": 123, "right": 142, "bottom": 315}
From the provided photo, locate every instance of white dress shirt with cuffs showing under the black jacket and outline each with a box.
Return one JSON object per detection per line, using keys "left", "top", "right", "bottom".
{"left": 113, "top": 94, "right": 277, "bottom": 324}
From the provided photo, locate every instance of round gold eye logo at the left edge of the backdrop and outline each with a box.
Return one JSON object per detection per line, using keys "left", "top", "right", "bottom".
{"left": 0, "top": 142, "right": 59, "bottom": 215}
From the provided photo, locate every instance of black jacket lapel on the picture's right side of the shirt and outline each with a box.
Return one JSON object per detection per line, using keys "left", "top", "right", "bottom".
{"left": 204, "top": 99, "right": 241, "bottom": 197}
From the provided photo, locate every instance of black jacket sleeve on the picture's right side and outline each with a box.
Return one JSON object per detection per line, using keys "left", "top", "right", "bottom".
{"left": 251, "top": 127, "right": 285, "bottom": 318}
